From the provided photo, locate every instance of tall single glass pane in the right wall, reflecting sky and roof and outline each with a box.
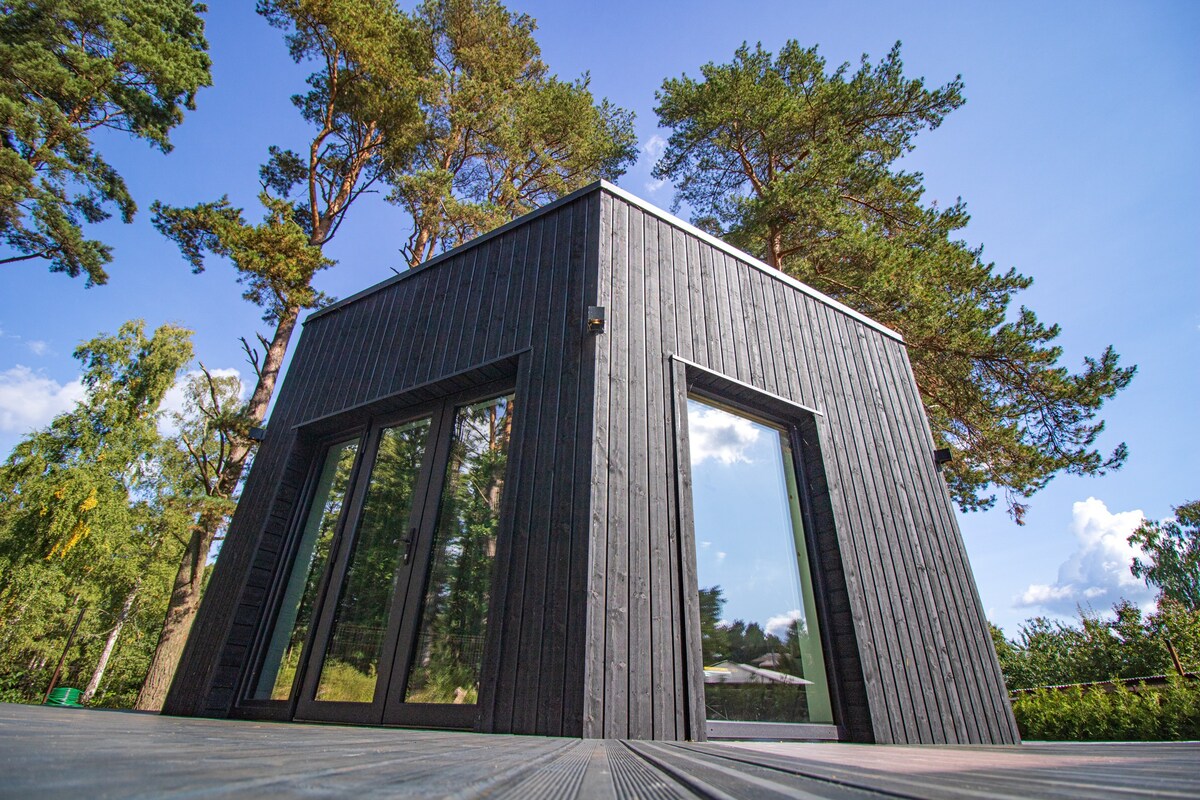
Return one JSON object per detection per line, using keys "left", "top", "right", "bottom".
{"left": 688, "top": 396, "right": 834, "bottom": 723}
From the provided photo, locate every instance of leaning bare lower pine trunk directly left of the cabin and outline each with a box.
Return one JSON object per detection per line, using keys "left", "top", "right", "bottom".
{"left": 134, "top": 306, "right": 300, "bottom": 711}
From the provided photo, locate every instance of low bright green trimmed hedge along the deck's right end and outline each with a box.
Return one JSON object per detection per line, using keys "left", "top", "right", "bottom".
{"left": 1013, "top": 675, "right": 1200, "bottom": 741}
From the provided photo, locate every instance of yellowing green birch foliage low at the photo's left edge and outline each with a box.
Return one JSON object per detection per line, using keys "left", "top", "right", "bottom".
{"left": 0, "top": 321, "right": 193, "bottom": 703}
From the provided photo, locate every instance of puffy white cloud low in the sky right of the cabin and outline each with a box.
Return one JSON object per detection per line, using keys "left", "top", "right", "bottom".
{"left": 1016, "top": 498, "right": 1154, "bottom": 615}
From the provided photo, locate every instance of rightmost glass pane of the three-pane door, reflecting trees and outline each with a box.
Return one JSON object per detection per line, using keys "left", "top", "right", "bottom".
{"left": 404, "top": 395, "right": 512, "bottom": 703}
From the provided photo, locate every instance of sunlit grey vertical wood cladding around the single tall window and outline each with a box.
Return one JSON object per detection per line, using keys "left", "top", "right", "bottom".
{"left": 583, "top": 192, "right": 1016, "bottom": 742}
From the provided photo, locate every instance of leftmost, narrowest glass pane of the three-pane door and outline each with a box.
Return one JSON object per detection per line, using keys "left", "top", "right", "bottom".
{"left": 254, "top": 440, "right": 359, "bottom": 700}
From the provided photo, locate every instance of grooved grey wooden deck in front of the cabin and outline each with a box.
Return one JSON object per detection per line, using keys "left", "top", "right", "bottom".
{"left": 0, "top": 704, "right": 1200, "bottom": 800}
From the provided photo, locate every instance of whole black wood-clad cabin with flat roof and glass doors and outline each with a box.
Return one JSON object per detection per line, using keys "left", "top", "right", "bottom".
{"left": 164, "top": 182, "right": 1018, "bottom": 744}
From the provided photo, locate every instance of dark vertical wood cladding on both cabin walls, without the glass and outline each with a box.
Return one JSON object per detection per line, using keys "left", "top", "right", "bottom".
{"left": 167, "top": 185, "right": 1016, "bottom": 742}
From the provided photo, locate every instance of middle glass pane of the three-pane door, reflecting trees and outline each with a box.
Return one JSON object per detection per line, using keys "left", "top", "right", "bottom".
{"left": 317, "top": 419, "right": 430, "bottom": 703}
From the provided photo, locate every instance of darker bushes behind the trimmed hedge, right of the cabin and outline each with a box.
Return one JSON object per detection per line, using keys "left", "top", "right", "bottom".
{"left": 992, "top": 600, "right": 1200, "bottom": 690}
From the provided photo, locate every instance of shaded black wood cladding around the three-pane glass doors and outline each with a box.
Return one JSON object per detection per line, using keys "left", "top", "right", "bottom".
{"left": 166, "top": 191, "right": 601, "bottom": 735}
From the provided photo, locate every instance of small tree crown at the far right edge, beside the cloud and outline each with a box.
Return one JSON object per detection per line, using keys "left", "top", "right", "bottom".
{"left": 1129, "top": 500, "right": 1200, "bottom": 612}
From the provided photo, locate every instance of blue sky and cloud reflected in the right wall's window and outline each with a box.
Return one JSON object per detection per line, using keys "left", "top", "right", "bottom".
{"left": 688, "top": 398, "right": 803, "bottom": 638}
